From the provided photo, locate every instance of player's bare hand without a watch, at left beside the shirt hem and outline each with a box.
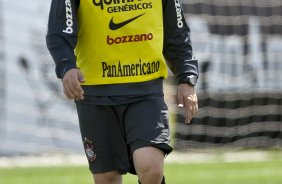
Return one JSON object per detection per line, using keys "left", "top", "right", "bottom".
{"left": 62, "top": 68, "right": 85, "bottom": 100}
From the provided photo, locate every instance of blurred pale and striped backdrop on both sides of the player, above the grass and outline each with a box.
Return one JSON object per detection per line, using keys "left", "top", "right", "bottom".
{"left": 0, "top": 0, "right": 282, "bottom": 183}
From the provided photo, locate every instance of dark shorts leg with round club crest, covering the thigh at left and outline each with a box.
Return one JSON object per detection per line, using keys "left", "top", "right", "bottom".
{"left": 77, "top": 103, "right": 129, "bottom": 174}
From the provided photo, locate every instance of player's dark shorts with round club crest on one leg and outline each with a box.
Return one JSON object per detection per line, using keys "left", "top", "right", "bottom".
{"left": 76, "top": 95, "right": 172, "bottom": 174}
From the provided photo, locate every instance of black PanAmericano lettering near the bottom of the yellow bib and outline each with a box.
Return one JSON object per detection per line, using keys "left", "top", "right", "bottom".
{"left": 101, "top": 59, "right": 160, "bottom": 78}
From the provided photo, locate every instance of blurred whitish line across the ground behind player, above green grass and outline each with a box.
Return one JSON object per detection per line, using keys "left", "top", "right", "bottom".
{"left": 0, "top": 151, "right": 282, "bottom": 168}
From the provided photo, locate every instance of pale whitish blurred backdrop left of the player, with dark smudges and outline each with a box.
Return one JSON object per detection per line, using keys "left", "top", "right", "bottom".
{"left": 0, "top": 0, "right": 82, "bottom": 156}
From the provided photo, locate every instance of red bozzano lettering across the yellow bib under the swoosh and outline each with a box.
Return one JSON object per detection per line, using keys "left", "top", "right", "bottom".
{"left": 107, "top": 33, "right": 154, "bottom": 45}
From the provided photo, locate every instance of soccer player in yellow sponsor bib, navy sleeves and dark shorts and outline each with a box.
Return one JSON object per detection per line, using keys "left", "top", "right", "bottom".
{"left": 46, "top": 0, "right": 198, "bottom": 184}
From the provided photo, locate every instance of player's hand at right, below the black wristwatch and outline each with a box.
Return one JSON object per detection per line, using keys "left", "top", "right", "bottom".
{"left": 177, "top": 84, "right": 198, "bottom": 124}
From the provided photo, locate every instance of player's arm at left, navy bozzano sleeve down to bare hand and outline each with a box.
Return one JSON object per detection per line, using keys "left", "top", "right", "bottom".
{"left": 46, "top": 0, "right": 84, "bottom": 99}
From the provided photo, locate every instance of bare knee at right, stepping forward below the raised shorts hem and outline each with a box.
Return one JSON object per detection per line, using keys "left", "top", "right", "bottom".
{"left": 133, "top": 147, "right": 164, "bottom": 184}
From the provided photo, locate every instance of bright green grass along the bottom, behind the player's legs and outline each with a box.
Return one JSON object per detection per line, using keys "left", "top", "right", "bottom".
{"left": 0, "top": 159, "right": 282, "bottom": 184}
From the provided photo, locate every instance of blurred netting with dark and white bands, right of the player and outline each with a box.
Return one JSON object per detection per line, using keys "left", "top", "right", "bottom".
{"left": 175, "top": 0, "right": 282, "bottom": 149}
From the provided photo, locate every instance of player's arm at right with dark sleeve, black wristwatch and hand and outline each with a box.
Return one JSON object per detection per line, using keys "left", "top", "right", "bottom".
{"left": 163, "top": 0, "right": 199, "bottom": 123}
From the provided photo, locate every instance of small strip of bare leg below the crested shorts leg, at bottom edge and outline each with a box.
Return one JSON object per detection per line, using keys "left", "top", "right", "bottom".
{"left": 93, "top": 171, "right": 122, "bottom": 184}
